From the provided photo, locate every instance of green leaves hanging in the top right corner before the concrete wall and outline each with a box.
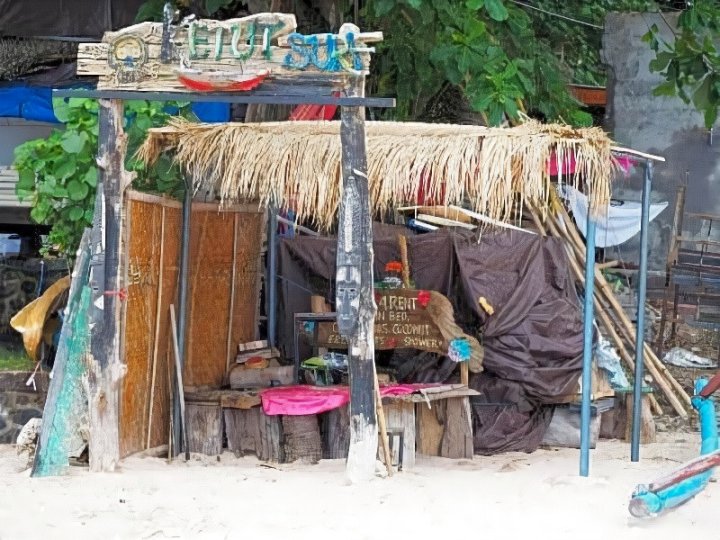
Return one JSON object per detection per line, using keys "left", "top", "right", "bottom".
{"left": 643, "top": 0, "right": 720, "bottom": 129}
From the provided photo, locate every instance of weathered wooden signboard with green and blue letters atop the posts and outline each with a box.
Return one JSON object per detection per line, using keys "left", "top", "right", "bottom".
{"left": 77, "top": 13, "right": 382, "bottom": 92}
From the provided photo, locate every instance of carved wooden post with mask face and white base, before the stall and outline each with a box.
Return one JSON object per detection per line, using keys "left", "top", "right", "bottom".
{"left": 336, "top": 77, "right": 378, "bottom": 482}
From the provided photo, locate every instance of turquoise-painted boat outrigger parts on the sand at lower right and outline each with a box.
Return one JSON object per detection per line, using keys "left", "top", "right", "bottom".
{"left": 630, "top": 379, "right": 718, "bottom": 517}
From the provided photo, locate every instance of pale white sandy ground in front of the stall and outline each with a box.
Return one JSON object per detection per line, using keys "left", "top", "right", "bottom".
{"left": 0, "top": 433, "right": 720, "bottom": 540}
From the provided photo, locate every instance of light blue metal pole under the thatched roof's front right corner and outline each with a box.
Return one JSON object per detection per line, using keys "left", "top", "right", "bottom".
{"left": 580, "top": 213, "right": 595, "bottom": 476}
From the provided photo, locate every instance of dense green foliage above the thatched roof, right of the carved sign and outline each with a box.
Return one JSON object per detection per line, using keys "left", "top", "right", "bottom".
{"left": 367, "top": 0, "right": 680, "bottom": 125}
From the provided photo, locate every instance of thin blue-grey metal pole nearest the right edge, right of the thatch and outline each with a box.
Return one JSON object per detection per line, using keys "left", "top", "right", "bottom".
{"left": 630, "top": 161, "right": 652, "bottom": 461}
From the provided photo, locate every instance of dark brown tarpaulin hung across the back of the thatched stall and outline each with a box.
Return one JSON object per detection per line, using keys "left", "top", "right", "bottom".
{"left": 279, "top": 224, "right": 583, "bottom": 453}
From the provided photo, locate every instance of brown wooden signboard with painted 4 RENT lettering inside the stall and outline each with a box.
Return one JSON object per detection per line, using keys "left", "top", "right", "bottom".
{"left": 317, "top": 289, "right": 482, "bottom": 371}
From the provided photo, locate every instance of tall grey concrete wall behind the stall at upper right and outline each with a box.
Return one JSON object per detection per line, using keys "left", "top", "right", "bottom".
{"left": 602, "top": 13, "right": 720, "bottom": 269}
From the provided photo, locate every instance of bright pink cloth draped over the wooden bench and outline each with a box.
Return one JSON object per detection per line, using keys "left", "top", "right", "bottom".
{"left": 260, "top": 384, "right": 437, "bottom": 416}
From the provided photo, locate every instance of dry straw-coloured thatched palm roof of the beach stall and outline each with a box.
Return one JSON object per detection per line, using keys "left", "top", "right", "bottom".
{"left": 139, "top": 121, "right": 615, "bottom": 229}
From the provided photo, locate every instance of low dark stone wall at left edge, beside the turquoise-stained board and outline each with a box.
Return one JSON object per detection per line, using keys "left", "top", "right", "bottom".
{"left": 0, "top": 371, "right": 49, "bottom": 444}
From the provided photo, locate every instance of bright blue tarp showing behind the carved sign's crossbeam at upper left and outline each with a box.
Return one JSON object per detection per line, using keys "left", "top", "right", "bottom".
{"left": 0, "top": 84, "right": 230, "bottom": 123}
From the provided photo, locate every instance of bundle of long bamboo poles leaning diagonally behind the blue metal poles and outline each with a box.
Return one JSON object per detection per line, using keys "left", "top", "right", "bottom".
{"left": 530, "top": 196, "right": 691, "bottom": 418}
